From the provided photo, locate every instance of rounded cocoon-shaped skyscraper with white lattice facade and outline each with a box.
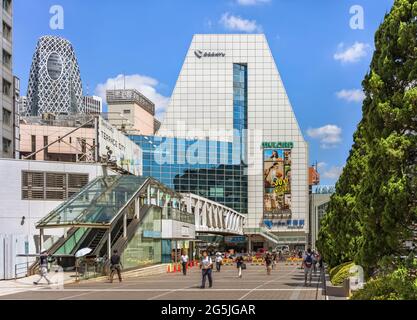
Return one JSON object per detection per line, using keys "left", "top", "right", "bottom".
{"left": 26, "top": 36, "right": 85, "bottom": 116}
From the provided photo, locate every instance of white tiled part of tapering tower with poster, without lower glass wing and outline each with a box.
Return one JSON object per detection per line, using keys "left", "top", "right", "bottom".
{"left": 158, "top": 34, "right": 309, "bottom": 250}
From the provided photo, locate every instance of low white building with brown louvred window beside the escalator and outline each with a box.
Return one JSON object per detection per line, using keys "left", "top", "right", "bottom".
{"left": 0, "top": 159, "right": 109, "bottom": 253}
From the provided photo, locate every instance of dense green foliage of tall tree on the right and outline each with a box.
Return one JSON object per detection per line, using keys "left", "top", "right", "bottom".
{"left": 318, "top": 0, "right": 417, "bottom": 275}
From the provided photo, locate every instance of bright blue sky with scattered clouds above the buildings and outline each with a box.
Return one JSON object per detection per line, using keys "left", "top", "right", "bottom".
{"left": 13, "top": 0, "right": 394, "bottom": 185}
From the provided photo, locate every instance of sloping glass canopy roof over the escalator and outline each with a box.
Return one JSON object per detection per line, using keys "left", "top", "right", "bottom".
{"left": 37, "top": 176, "right": 150, "bottom": 228}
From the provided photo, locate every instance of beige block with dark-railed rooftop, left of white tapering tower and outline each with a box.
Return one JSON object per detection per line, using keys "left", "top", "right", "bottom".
{"left": 106, "top": 89, "right": 158, "bottom": 135}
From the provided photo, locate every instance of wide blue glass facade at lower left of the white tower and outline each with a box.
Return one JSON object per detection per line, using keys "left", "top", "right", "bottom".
{"left": 130, "top": 136, "right": 248, "bottom": 213}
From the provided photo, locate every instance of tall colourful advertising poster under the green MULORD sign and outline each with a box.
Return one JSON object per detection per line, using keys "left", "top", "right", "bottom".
{"left": 264, "top": 149, "right": 291, "bottom": 220}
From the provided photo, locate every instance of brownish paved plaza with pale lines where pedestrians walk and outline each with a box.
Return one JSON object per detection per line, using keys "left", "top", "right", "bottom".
{"left": 0, "top": 263, "right": 325, "bottom": 301}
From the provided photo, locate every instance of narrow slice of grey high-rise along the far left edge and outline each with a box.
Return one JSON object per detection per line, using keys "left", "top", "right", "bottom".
{"left": 0, "top": 0, "right": 14, "bottom": 158}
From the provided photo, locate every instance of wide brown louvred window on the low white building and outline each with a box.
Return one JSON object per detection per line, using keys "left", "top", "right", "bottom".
{"left": 22, "top": 171, "right": 88, "bottom": 201}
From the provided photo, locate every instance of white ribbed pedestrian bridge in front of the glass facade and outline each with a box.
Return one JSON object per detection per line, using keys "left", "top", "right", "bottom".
{"left": 183, "top": 193, "right": 246, "bottom": 235}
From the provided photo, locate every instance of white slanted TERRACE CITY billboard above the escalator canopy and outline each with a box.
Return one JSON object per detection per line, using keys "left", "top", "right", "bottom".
{"left": 98, "top": 117, "right": 142, "bottom": 176}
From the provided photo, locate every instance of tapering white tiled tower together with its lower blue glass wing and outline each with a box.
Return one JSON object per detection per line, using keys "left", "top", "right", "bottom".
{"left": 153, "top": 34, "right": 309, "bottom": 250}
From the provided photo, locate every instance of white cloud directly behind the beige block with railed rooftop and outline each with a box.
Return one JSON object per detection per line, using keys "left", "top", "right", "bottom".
{"left": 95, "top": 74, "right": 170, "bottom": 117}
